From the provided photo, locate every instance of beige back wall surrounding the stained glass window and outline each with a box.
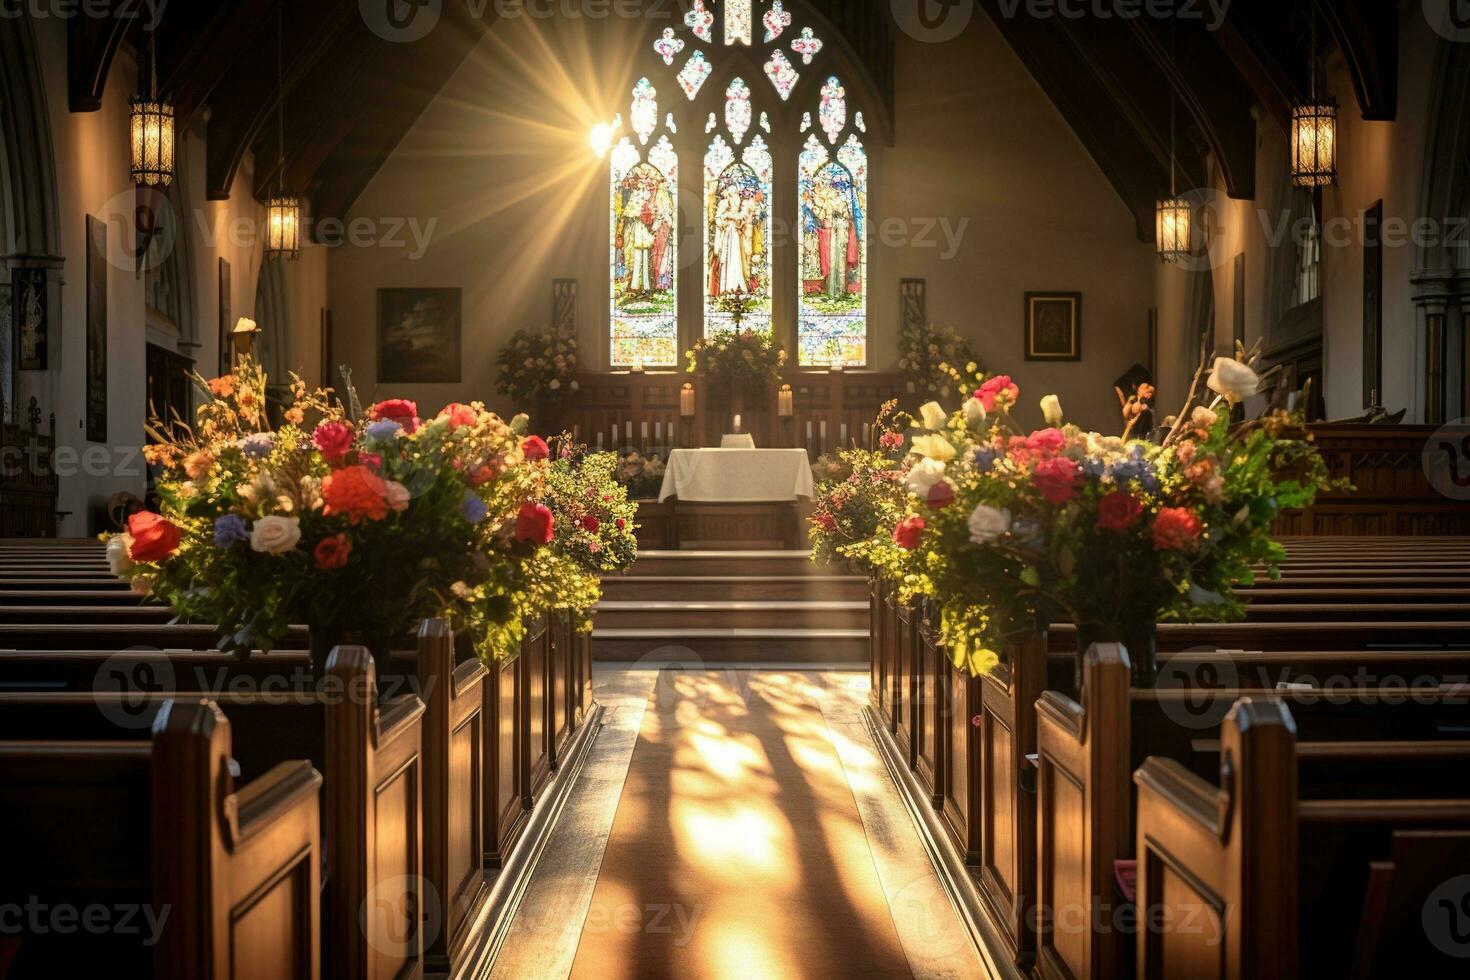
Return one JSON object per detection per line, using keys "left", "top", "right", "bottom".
{"left": 330, "top": 5, "right": 1154, "bottom": 429}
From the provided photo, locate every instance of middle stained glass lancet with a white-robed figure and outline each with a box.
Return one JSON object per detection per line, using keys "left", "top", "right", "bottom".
{"left": 704, "top": 134, "right": 772, "bottom": 334}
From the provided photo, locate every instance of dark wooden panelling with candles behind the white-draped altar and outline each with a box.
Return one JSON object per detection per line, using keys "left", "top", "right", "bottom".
{"left": 532, "top": 370, "right": 913, "bottom": 460}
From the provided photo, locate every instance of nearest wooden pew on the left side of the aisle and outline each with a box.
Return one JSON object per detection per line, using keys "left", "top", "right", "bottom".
{"left": 0, "top": 698, "right": 322, "bottom": 980}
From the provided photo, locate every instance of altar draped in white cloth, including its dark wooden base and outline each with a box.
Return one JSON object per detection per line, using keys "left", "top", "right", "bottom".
{"left": 639, "top": 448, "right": 813, "bottom": 551}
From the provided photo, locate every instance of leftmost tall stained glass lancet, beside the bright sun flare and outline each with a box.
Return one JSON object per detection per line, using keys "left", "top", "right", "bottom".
{"left": 610, "top": 78, "right": 679, "bottom": 367}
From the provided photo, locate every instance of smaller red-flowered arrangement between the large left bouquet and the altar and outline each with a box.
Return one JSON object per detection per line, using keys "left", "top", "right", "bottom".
{"left": 453, "top": 436, "right": 638, "bottom": 658}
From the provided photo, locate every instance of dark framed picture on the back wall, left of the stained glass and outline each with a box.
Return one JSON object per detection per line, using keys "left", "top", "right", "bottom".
{"left": 378, "top": 288, "right": 460, "bottom": 383}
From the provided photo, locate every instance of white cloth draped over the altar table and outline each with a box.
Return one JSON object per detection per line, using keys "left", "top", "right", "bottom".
{"left": 659, "top": 450, "right": 811, "bottom": 502}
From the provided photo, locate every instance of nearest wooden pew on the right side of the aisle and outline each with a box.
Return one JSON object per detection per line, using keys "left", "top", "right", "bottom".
{"left": 1135, "top": 698, "right": 1470, "bottom": 977}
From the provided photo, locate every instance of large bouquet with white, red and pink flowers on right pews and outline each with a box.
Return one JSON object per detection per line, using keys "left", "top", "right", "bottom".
{"left": 878, "top": 356, "right": 1330, "bottom": 686}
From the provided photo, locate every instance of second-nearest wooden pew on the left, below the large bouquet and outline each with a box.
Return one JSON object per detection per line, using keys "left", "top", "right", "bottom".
{"left": 0, "top": 646, "right": 425, "bottom": 979}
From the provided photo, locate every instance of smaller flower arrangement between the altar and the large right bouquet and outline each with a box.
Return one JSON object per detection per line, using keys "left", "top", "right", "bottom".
{"left": 807, "top": 403, "right": 907, "bottom": 570}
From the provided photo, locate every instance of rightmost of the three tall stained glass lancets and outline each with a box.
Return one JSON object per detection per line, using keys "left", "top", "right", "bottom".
{"left": 797, "top": 132, "right": 867, "bottom": 366}
